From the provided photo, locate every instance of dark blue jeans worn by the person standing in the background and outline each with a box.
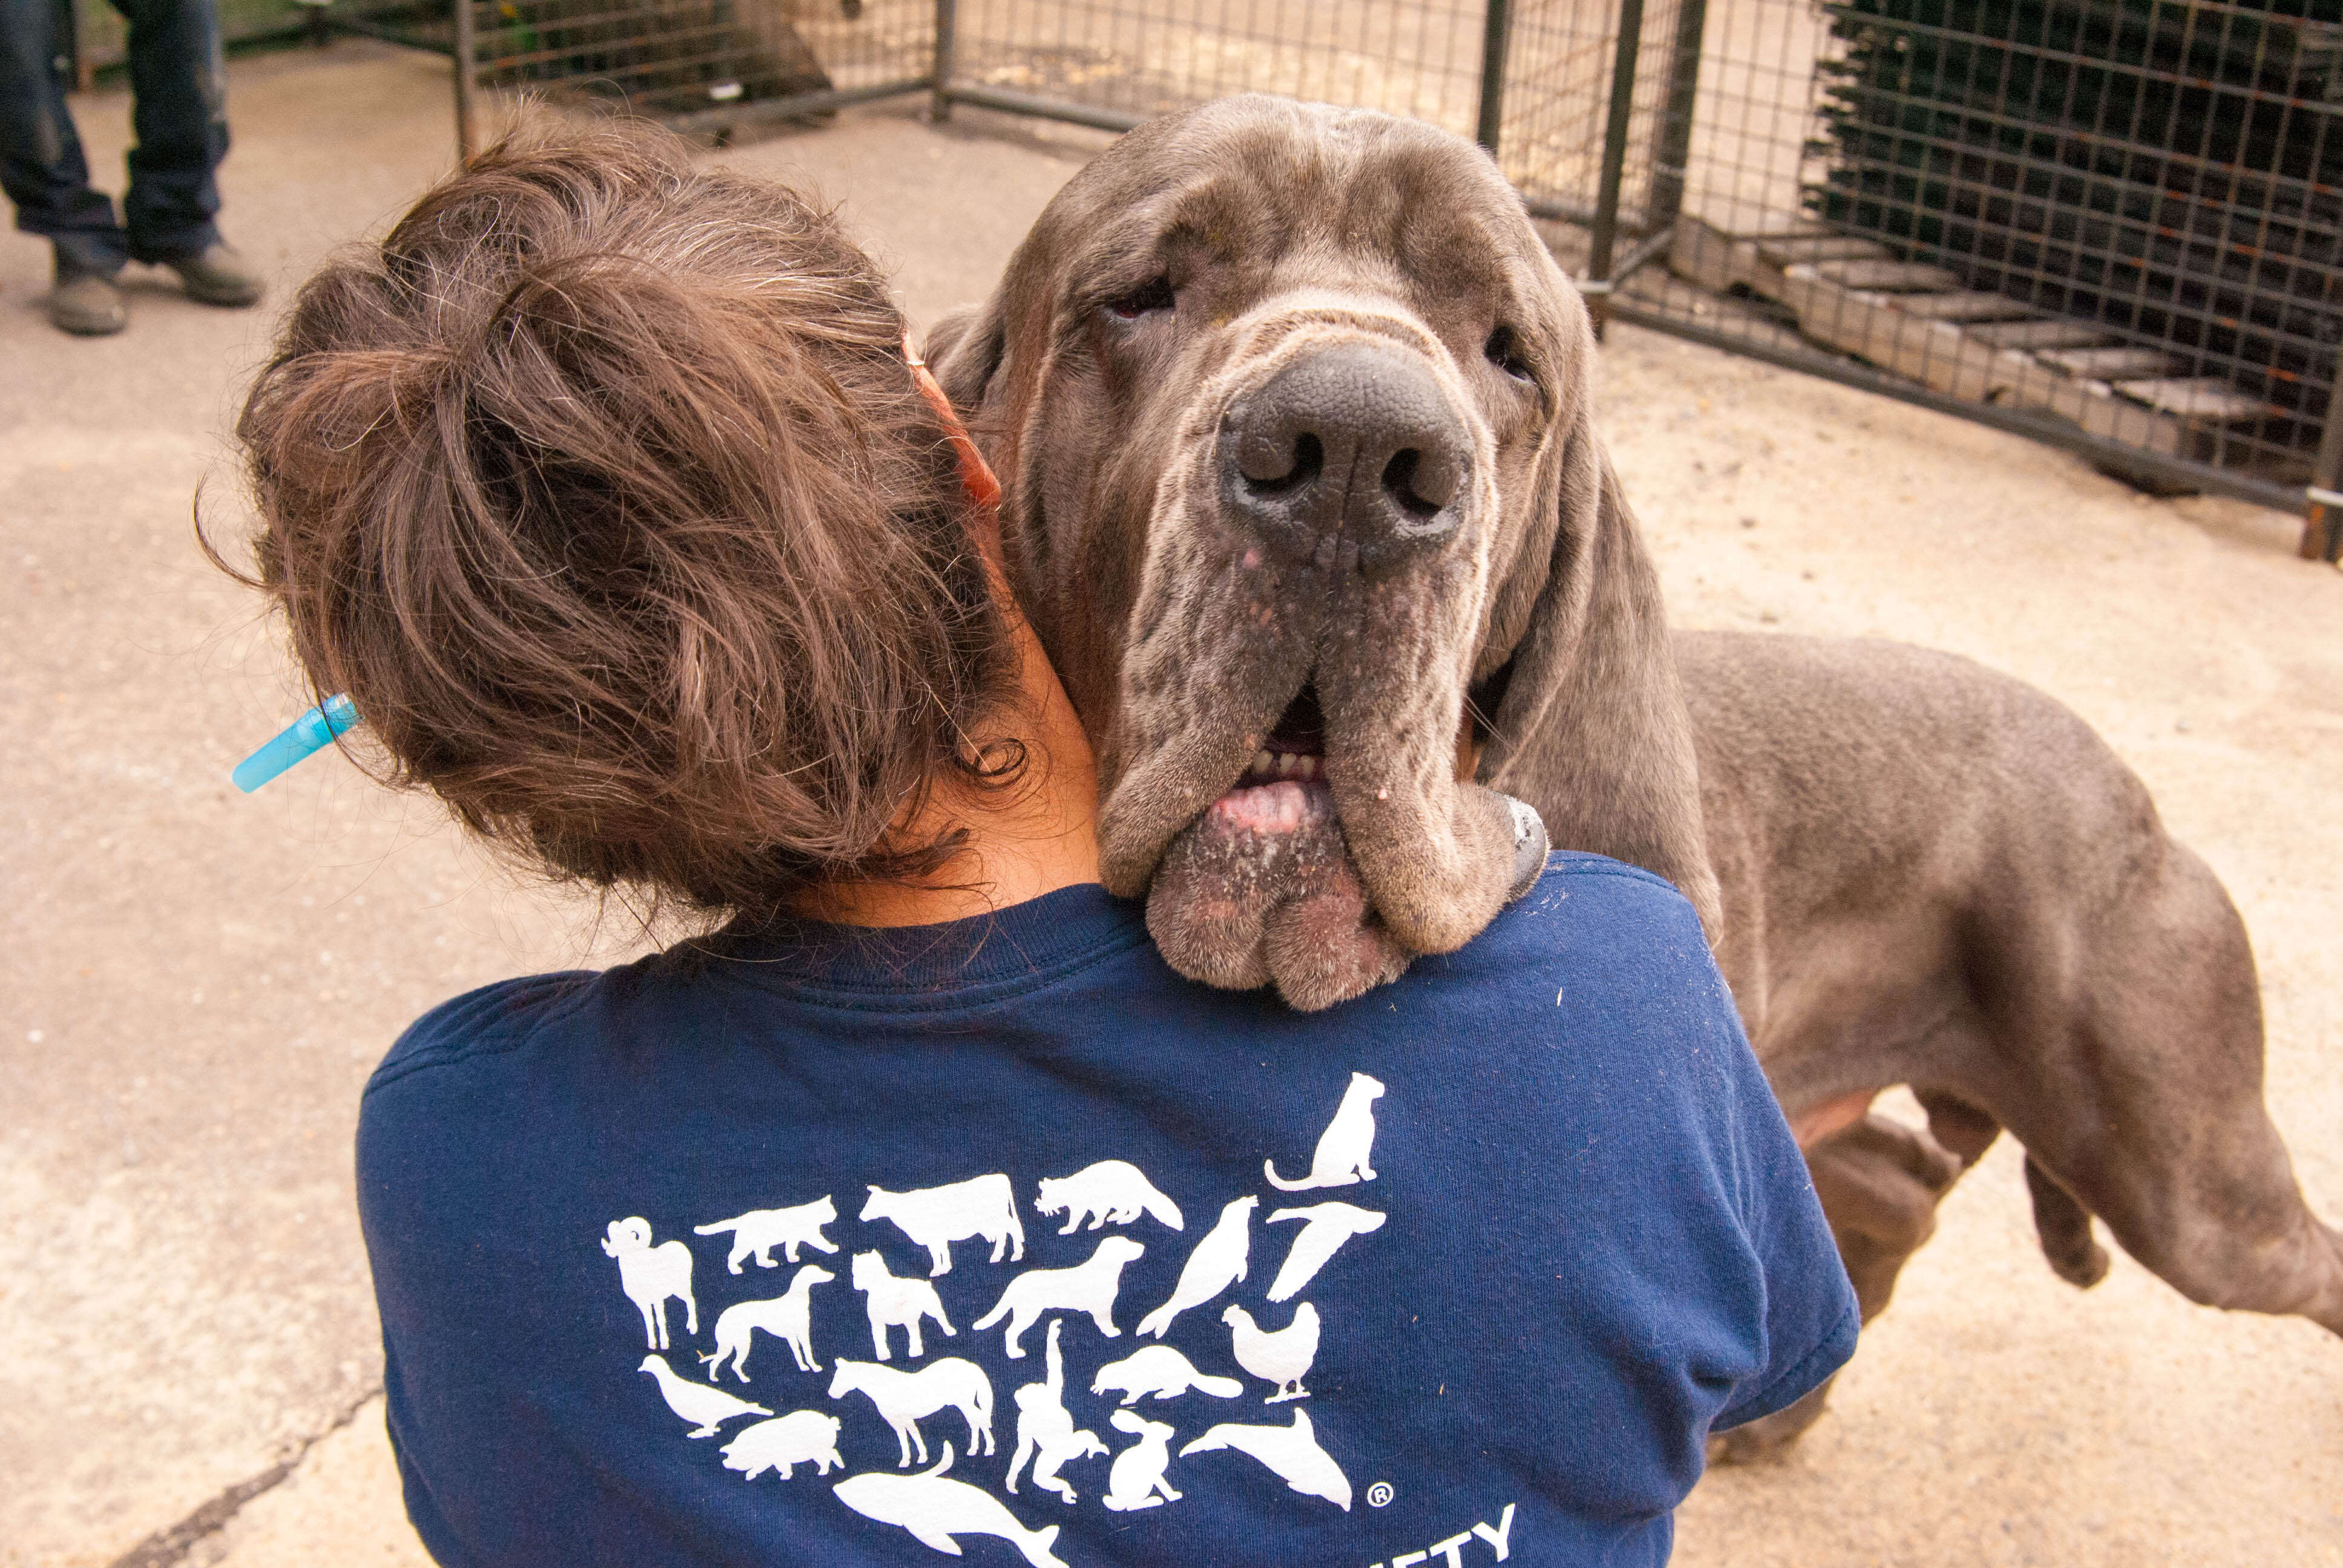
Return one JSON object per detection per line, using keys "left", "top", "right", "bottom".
{"left": 0, "top": 0, "right": 228, "bottom": 272}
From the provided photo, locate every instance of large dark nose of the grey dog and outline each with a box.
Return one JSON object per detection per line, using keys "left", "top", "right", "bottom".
{"left": 1221, "top": 342, "right": 1472, "bottom": 574}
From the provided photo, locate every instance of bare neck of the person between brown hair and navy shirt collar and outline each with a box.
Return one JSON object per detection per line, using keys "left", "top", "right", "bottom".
{"left": 799, "top": 579, "right": 1099, "bottom": 926}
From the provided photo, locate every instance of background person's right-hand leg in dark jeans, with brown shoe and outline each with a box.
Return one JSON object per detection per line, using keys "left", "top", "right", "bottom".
{"left": 113, "top": 0, "right": 260, "bottom": 305}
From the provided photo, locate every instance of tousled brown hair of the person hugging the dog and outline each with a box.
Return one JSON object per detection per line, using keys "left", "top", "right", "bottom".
{"left": 206, "top": 126, "right": 1021, "bottom": 914}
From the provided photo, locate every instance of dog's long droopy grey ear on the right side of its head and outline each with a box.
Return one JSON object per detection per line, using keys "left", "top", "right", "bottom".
{"left": 1481, "top": 401, "right": 1720, "bottom": 940}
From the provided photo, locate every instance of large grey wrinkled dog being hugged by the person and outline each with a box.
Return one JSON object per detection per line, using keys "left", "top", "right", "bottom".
{"left": 928, "top": 99, "right": 2343, "bottom": 1455}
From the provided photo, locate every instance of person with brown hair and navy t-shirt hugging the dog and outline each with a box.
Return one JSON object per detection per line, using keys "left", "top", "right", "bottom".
{"left": 239, "top": 129, "right": 1856, "bottom": 1568}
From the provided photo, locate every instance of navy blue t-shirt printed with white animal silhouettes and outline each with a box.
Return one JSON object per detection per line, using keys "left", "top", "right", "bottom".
{"left": 358, "top": 855, "right": 1856, "bottom": 1568}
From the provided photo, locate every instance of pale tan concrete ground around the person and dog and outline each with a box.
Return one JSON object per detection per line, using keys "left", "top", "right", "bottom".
{"left": 0, "top": 45, "right": 2343, "bottom": 1568}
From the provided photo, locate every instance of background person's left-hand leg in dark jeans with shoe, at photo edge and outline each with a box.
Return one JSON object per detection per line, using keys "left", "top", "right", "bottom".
{"left": 0, "top": 0, "right": 129, "bottom": 333}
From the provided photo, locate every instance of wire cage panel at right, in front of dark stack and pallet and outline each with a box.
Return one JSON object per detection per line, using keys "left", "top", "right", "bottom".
{"left": 1619, "top": 0, "right": 2343, "bottom": 543}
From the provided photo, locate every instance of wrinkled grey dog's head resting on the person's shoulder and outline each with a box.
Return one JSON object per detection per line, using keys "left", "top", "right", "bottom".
{"left": 928, "top": 96, "right": 1715, "bottom": 1005}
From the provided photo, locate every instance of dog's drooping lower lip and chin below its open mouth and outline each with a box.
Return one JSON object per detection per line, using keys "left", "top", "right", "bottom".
{"left": 1148, "top": 780, "right": 1411, "bottom": 1013}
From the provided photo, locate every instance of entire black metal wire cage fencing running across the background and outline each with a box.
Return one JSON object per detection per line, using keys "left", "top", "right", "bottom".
{"left": 407, "top": 0, "right": 2343, "bottom": 560}
